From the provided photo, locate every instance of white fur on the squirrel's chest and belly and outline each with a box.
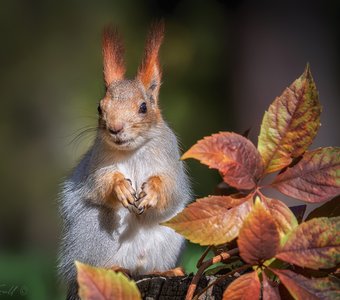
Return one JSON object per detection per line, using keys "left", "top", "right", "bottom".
{"left": 105, "top": 156, "right": 184, "bottom": 274}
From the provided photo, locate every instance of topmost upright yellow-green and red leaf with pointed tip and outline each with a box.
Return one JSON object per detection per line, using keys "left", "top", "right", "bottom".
{"left": 258, "top": 66, "right": 321, "bottom": 173}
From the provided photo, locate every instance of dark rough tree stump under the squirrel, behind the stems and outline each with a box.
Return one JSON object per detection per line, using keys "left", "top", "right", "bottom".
{"left": 133, "top": 274, "right": 235, "bottom": 300}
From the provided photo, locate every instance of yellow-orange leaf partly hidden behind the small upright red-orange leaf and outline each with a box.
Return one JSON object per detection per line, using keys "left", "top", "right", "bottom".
{"left": 261, "top": 196, "right": 299, "bottom": 237}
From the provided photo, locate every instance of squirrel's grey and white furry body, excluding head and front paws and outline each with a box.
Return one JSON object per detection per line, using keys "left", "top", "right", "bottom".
{"left": 59, "top": 121, "right": 191, "bottom": 299}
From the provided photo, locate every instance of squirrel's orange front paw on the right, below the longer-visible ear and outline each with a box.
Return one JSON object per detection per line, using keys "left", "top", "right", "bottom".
{"left": 135, "top": 176, "right": 161, "bottom": 214}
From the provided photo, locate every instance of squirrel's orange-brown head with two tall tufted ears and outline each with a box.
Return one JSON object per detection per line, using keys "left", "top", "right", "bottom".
{"left": 98, "top": 22, "right": 164, "bottom": 150}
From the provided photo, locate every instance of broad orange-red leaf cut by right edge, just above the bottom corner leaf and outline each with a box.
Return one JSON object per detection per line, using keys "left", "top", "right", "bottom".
{"left": 276, "top": 217, "right": 340, "bottom": 270}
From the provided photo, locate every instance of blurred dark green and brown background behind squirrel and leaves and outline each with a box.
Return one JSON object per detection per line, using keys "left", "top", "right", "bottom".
{"left": 0, "top": 0, "right": 340, "bottom": 300}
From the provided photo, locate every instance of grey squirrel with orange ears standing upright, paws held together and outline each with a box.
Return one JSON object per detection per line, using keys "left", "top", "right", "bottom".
{"left": 58, "top": 22, "right": 191, "bottom": 299}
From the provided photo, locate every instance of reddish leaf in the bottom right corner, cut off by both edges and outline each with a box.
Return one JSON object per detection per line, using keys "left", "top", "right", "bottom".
{"left": 271, "top": 269, "right": 340, "bottom": 300}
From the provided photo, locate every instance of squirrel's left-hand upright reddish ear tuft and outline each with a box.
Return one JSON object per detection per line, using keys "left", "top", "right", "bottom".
{"left": 103, "top": 26, "right": 125, "bottom": 87}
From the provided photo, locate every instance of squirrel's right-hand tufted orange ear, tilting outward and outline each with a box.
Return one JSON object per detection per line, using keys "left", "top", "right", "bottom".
{"left": 137, "top": 21, "right": 164, "bottom": 101}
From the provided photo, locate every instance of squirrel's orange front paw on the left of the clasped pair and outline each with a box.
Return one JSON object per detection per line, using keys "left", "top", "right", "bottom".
{"left": 113, "top": 177, "right": 136, "bottom": 212}
